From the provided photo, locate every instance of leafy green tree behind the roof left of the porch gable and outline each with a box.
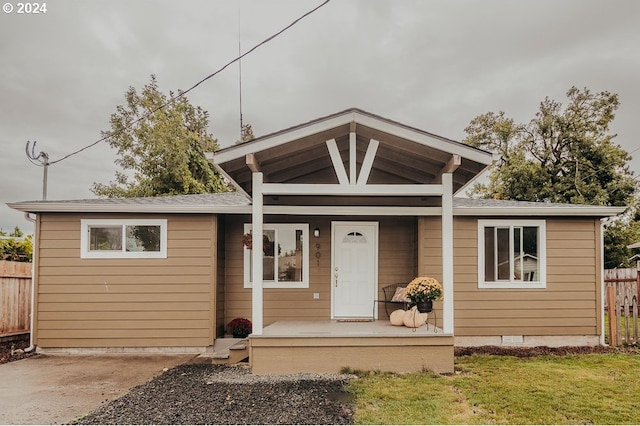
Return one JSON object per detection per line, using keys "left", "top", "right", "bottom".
{"left": 91, "top": 75, "right": 227, "bottom": 197}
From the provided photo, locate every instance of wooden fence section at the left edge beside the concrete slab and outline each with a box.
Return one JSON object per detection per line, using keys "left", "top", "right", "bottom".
{"left": 0, "top": 260, "right": 31, "bottom": 337}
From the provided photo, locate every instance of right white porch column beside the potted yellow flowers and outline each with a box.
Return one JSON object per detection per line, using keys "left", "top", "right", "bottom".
{"left": 442, "top": 173, "right": 453, "bottom": 334}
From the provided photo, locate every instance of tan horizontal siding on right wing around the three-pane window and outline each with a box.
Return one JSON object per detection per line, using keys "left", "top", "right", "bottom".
{"left": 419, "top": 217, "right": 601, "bottom": 336}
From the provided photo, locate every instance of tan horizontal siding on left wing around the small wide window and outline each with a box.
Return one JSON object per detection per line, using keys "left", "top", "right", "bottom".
{"left": 36, "top": 214, "right": 218, "bottom": 348}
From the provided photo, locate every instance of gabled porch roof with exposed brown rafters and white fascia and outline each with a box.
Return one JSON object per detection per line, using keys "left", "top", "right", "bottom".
{"left": 213, "top": 109, "right": 492, "bottom": 201}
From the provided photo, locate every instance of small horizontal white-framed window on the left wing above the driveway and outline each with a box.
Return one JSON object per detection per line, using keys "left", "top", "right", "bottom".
{"left": 80, "top": 219, "right": 167, "bottom": 259}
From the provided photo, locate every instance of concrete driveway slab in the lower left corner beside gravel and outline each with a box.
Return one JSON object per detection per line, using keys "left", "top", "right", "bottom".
{"left": 0, "top": 354, "right": 194, "bottom": 424}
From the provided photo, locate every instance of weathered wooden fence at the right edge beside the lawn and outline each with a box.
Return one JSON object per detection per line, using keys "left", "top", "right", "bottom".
{"left": 604, "top": 267, "right": 640, "bottom": 346}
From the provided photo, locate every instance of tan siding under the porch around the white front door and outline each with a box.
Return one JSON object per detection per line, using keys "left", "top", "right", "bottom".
{"left": 225, "top": 216, "right": 416, "bottom": 325}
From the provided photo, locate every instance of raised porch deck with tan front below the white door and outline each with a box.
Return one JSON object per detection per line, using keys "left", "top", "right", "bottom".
{"left": 249, "top": 320, "right": 453, "bottom": 374}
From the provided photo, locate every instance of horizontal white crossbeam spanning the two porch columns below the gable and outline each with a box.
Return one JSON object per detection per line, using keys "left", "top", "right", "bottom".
{"left": 262, "top": 183, "right": 442, "bottom": 197}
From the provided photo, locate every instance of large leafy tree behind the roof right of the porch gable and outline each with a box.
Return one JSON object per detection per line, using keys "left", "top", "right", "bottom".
{"left": 464, "top": 87, "right": 640, "bottom": 266}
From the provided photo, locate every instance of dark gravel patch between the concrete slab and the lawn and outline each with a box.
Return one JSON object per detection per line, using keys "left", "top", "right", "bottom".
{"left": 75, "top": 364, "right": 353, "bottom": 424}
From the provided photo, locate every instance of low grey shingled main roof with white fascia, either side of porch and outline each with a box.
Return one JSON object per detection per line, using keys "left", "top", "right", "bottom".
{"left": 7, "top": 192, "right": 625, "bottom": 217}
